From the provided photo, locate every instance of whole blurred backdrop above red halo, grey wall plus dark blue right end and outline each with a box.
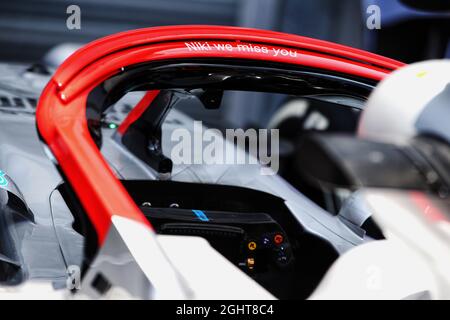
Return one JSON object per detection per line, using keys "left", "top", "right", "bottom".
{"left": 0, "top": 0, "right": 450, "bottom": 62}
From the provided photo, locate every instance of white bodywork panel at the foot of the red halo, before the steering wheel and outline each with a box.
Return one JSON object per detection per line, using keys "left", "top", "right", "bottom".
{"left": 80, "top": 216, "right": 274, "bottom": 299}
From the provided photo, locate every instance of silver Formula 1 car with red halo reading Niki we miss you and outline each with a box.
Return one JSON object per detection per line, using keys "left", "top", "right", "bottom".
{"left": 0, "top": 26, "right": 444, "bottom": 299}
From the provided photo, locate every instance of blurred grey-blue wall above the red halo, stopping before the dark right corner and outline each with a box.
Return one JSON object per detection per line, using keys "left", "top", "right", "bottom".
{"left": 0, "top": 0, "right": 363, "bottom": 62}
